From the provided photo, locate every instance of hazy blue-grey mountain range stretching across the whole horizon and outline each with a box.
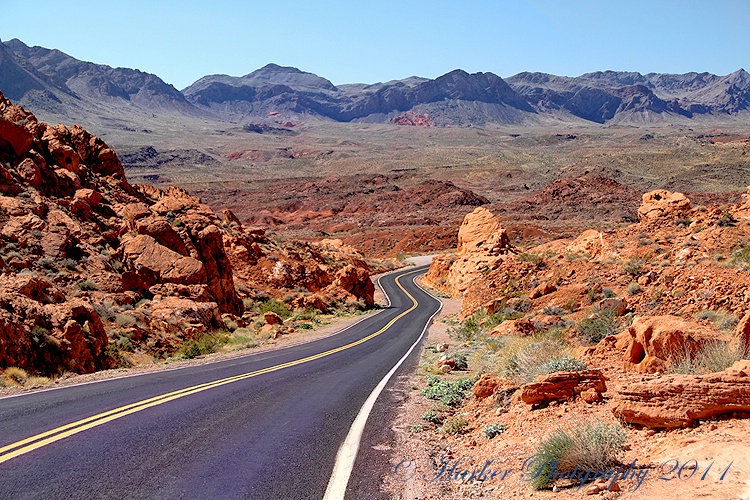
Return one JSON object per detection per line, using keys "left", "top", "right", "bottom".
{"left": 0, "top": 39, "right": 750, "bottom": 127}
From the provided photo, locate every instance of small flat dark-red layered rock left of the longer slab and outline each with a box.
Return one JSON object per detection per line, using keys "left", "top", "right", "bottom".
{"left": 520, "top": 370, "right": 607, "bottom": 405}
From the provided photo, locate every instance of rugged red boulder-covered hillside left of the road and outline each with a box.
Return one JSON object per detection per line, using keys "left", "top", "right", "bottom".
{"left": 0, "top": 94, "right": 374, "bottom": 374}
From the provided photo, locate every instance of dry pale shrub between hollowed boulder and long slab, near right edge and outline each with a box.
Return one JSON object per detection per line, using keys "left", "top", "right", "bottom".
{"left": 668, "top": 340, "right": 750, "bottom": 375}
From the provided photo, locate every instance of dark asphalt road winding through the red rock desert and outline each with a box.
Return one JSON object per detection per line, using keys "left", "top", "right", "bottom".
{"left": 0, "top": 267, "right": 439, "bottom": 499}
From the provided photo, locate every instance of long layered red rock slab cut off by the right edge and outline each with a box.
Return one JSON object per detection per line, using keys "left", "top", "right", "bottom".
{"left": 612, "top": 360, "right": 750, "bottom": 429}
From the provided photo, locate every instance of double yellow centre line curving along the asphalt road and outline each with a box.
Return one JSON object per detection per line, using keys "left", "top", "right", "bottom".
{"left": 0, "top": 271, "right": 419, "bottom": 463}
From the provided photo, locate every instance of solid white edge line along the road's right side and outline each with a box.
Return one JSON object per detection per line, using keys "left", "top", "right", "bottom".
{"left": 323, "top": 276, "right": 443, "bottom": 500}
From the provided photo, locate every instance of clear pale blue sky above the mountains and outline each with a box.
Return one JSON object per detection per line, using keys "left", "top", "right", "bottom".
{"left": 0, "top": 0, "right": 750, "bottom": 89}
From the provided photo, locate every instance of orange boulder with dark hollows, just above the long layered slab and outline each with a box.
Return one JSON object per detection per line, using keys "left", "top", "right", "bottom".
{"left": 624, "top": 316, "right": 726, "bottom": 373}
